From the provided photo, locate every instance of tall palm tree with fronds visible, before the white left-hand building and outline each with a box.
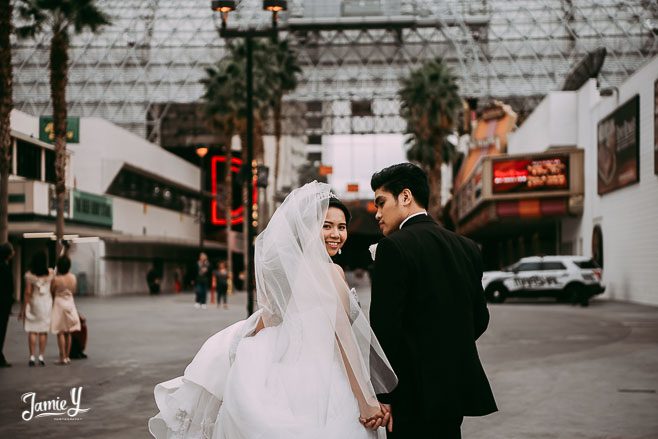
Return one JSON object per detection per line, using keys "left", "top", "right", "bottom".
{"left": 17, "top": 0, "right": 110, "bottom": 254}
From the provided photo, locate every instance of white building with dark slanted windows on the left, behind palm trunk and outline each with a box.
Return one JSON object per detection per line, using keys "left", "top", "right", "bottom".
{"left": 9, "top": 111, "right": 213, "bottom": 297}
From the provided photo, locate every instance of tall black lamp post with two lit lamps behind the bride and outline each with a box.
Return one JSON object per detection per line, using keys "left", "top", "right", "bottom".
{"left": 210, "top": 0, "right": 287, "bottom": 315}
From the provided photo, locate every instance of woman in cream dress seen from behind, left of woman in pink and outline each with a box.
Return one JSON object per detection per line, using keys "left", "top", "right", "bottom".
{"left": 18, "top": 251, "right": 54, "bottom": 367}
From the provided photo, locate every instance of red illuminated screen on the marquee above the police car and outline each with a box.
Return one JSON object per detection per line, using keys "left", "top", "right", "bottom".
{"left": 492, "top": 155, "right": 569, "bottom": 194}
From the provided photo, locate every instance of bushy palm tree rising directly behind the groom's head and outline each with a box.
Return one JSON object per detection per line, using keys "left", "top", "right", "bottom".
{"left": 399, "top": 58, "right": 461, "bottom": 219}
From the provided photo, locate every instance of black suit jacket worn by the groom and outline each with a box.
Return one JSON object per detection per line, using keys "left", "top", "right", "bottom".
{"left": 370, "top": 215, "right": 497, "bottom": 420}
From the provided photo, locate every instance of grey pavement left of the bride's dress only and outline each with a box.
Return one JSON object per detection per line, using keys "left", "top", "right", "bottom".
{"left": 0, "top": 293, "right": 246, "bottom": 439}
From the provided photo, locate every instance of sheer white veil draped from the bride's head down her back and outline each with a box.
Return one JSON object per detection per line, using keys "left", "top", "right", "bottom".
{"left": 255, "top": 182, "right": 397, "bottom": 423}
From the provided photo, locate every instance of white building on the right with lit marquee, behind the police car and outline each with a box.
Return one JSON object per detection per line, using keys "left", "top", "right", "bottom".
{"left": 455, "top": 57, "right": 658, "bottom": 305}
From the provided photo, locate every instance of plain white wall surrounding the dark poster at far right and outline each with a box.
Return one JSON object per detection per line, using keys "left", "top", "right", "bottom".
{"left": 579, "top": 57, "right": 658, "bottom": 305}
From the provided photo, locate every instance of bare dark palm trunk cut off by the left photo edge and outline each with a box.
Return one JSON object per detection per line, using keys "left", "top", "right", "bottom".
{"left": 0, "top": 0, "right": 13, "bottom": 244}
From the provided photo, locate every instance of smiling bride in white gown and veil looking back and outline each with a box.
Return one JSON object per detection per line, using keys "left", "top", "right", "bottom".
{"left": 149, "top": 182, "right": 397, "bottom": 439}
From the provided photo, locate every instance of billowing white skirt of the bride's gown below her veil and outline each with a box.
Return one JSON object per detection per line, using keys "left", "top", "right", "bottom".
{"left": 149, "top": 306, "right": 386, "bottom": 439}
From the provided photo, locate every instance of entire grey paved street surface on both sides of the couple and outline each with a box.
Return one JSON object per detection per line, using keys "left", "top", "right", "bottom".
{"left": 0, "top": 288, "right": 658, "bottom": 439}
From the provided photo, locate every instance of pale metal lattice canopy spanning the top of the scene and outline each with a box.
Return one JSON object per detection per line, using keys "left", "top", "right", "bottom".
{"left": 13, "top": 0, "right": 658, "bottom": 143}
